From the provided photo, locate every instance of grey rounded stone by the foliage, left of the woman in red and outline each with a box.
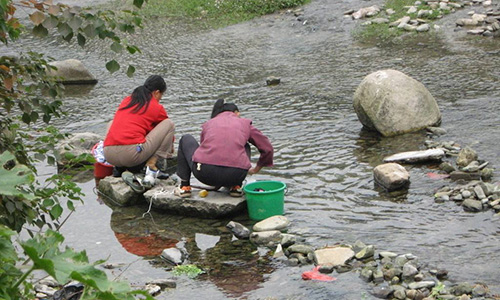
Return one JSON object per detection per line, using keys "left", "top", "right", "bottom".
{"left": 56, "top": 132, "right": 103, "bottom": 166}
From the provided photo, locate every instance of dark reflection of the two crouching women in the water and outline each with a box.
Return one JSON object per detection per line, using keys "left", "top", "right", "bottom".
{"left": 111, "top": 206, "right": 275, "bottom": 297}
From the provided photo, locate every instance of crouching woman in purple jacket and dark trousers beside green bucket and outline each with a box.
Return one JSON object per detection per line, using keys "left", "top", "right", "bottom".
{"left": 175, "top": 99, "right": 273, "bottom": 197}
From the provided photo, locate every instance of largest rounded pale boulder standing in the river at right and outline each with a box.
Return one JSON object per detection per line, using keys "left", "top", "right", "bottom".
{"left": 353, "top": 70, "right": 441, "bottom": 136}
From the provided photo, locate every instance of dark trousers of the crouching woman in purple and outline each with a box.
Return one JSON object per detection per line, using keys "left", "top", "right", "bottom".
{"left": 177, "top": 134, "right": 250, "bottom": 187}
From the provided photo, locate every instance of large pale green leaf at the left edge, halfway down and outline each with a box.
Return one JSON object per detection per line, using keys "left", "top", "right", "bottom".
{"left": 0, "top": 151, "right": 35, "bottom": 199}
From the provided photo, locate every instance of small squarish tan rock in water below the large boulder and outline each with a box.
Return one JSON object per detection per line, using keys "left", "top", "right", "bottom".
{"left": 373, "top": 163, "right": 410, "bottom": 191}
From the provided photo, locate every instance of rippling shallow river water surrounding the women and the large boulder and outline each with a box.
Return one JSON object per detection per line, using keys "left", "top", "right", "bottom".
{"left": 8, "top": 0, "right": 500, "bottom": 299}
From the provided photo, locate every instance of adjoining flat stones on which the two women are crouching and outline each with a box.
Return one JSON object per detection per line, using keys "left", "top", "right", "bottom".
{"left": 98, "top": 176, "right": 246, "bottom": 218}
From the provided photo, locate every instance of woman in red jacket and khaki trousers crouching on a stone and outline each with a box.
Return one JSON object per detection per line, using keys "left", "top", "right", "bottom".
{"left": 104, "top": 75, "right": 175, "bottom": 187}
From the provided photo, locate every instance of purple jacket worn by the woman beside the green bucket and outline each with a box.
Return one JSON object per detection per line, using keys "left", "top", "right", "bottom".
{"left": 193, "top": 111, "right": 273, "bottom": 170}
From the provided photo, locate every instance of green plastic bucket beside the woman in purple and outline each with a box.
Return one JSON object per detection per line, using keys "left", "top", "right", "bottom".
{"left": 243, "top": 181, "right": 286, "bottom": 221}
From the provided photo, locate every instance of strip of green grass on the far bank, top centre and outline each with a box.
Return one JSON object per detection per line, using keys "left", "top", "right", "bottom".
{"left": 141, "top": 0, "right": 310, "bottom": 27}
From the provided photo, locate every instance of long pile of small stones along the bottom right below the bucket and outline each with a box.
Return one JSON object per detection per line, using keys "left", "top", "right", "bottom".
{"left": 226, "top": 216, "right": 494, "bottom": 300}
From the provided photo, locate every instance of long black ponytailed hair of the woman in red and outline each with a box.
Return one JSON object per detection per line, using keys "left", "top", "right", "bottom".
{"left": 122, "top": 75, "right": 167, "bottom": 114}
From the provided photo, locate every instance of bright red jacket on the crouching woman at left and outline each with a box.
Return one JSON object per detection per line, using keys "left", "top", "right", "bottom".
{"left": 104, "top": 96, "right": 168, "bottom": 147}
